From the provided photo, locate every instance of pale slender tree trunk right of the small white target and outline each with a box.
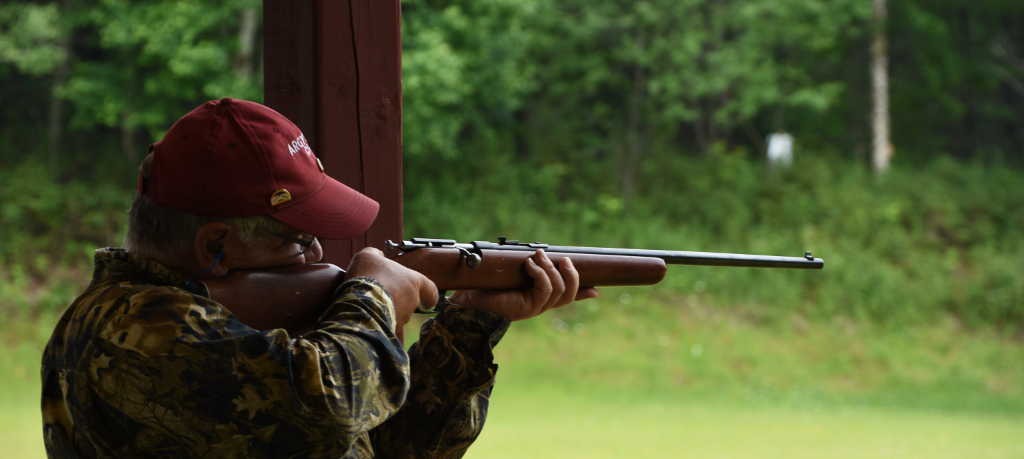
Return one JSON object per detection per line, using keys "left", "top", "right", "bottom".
{"left": 871, "top": 0, "right": 893, "bottom": 174}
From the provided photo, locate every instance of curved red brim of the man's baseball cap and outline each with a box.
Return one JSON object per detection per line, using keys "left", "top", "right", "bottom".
{"left": 270, "top": 177, "right": 380, "bottom": 239}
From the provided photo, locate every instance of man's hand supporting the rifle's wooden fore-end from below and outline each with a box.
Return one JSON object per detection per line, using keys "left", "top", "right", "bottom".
{"left": 452, "top": 250, "right": 597, "bottom": 321}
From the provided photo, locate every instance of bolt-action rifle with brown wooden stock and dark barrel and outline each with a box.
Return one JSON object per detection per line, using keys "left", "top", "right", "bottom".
{"left": 206, "top": 238, "right": 824, "bottom": 333}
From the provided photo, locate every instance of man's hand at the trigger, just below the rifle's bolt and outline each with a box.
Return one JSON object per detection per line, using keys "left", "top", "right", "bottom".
{"left": 347, "top": 247, "right": 437, "bottom": 340}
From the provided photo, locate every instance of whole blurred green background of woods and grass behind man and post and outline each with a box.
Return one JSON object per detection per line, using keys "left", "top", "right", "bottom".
{"left": 0, "top": 0, "right": 1024, "bottom": 457}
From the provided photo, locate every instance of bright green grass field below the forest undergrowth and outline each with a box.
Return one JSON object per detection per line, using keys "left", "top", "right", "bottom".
{"left": 0, "top": 291, "right": 1024, "bottom": 458}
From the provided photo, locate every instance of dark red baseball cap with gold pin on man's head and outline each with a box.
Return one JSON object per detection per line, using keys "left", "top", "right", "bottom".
{"left": 139, "top": 98, "right": 380, "bottom": 239}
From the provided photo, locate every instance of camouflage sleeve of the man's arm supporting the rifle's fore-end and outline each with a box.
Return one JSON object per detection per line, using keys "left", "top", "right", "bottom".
{"left": 370, "top": 305, "right": 509, "bottom": 459}
